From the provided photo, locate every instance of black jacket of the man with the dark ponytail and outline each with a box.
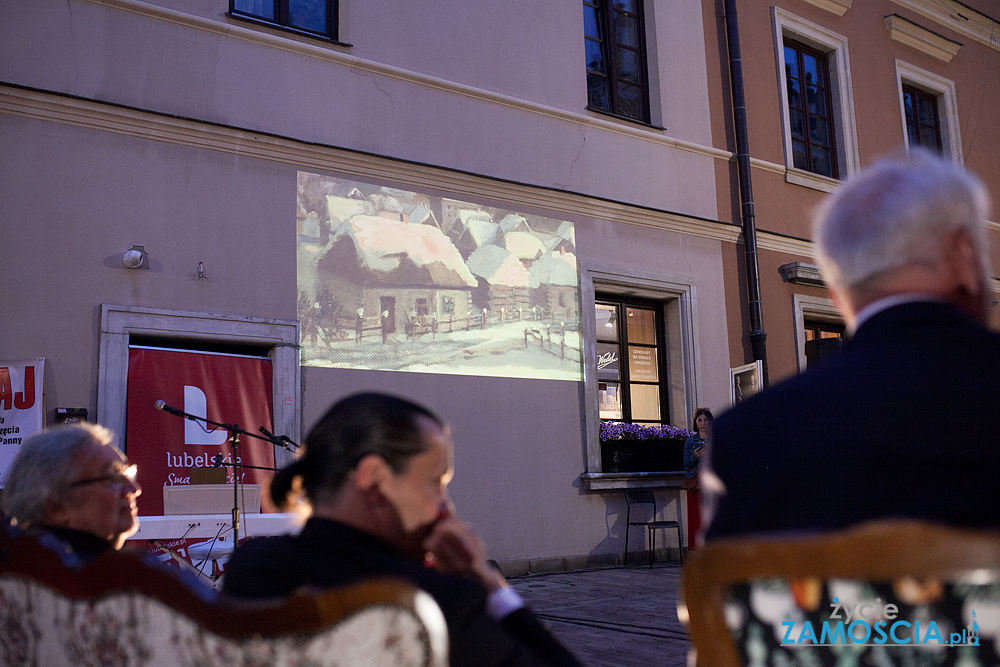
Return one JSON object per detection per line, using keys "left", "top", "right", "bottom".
{"left": 223, "top": 517, "right": 578, "bottom": 666}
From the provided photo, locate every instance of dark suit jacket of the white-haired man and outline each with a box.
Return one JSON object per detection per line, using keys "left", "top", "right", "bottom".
{"left": 706, "top": 302, "right": 1000, "bottom": 539}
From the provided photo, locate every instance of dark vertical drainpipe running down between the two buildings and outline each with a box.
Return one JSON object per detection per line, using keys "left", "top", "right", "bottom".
{"left": 725, "top": 0, "right": 768, "bottom": 387}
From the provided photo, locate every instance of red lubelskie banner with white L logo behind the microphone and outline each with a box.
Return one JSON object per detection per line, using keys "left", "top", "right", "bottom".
{"left": 125, "top": 346, "right": 274, "bottom": 516}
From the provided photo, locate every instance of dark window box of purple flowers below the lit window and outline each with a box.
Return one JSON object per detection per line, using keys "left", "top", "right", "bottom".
{"left": 600, "top": 420, "right": 691, "bottom": 472}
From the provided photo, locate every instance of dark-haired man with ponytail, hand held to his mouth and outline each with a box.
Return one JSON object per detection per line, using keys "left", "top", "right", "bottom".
{"left": 223, "top": 394, "right": 578, "bottom": 666}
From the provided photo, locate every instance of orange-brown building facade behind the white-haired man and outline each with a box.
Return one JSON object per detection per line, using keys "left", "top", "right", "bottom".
{"left": 706, "top": 0, "right": 1000, "bottom": 383}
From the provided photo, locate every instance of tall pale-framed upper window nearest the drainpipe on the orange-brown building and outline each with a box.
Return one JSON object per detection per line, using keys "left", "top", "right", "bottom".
{"left": 772, "top": 7, "right": 859, "bottom": 192}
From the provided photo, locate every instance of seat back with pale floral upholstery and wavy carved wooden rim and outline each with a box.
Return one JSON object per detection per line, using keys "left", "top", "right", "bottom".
{"left": 0, "top": 525, "right": 448, "bottom": 667}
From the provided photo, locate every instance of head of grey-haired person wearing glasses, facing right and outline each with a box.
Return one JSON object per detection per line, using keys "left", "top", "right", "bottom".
{"left": 0, "top": 423, "right": 142, "bottom": 562}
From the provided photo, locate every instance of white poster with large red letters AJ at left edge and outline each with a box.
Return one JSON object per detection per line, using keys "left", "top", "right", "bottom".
{"left": 0, "top": 357, "right": 45, "bottom": 488}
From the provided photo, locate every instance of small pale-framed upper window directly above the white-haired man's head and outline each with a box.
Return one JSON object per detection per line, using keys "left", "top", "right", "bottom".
{"left": 896, "top": 60, "right": 962, "bottom": 164}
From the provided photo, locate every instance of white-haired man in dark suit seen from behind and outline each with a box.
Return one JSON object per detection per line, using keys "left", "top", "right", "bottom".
{"left": 706, "top": 153, "right": 1000, "bottom": 540}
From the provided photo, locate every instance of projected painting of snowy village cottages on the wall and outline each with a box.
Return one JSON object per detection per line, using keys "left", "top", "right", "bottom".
{"left": 296, "top": 172, "right": 583, "bottom": 381}
